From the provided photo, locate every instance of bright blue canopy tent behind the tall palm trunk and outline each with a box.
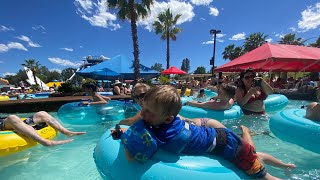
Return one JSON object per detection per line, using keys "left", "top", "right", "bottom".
{"left": 77, "top": 55, "right": 159, "bottom": 79}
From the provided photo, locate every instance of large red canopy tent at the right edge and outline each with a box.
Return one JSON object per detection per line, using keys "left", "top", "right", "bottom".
{"left": 215, "top": 43, "right": 320, "bottom": 72}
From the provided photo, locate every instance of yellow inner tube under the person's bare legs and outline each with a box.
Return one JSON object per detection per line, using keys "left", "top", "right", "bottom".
{"left": 0, "top": 118, "right": 57, "bottom": 157}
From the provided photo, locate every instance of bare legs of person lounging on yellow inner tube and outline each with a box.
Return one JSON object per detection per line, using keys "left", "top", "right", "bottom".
{"left": 0, "top": 111, "right": 85, "bottom": 146}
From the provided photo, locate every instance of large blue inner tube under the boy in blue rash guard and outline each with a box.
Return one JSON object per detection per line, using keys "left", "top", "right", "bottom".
{"left": 93, "top": 126, "right": 248, "bottom": 180}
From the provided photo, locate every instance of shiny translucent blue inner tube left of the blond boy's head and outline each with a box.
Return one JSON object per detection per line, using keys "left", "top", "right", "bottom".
{"left": 58, "top": 100, "right": 125, "bottom": 125}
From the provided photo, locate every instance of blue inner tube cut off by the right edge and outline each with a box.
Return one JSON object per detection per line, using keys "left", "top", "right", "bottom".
{"left": 269, "top": 109, "right": 320, "bottom": 153}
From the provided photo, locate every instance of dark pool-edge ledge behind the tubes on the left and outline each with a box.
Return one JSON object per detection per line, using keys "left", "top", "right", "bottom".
{"left": 0, "top": 95, "right": 131, "bottom": 113}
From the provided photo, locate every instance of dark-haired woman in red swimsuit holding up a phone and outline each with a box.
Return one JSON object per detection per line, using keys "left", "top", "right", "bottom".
{"left": 236, "top": 68, "right": 273, "bottom": 114}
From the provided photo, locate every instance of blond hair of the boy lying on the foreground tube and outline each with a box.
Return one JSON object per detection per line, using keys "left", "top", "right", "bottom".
{"left": 144, "top": 85, "right": 182, "bottom": 116}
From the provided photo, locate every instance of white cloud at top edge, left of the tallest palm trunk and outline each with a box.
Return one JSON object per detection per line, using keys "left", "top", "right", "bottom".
{"left": 74, "top": 0, "right": 120, "bottom": 30}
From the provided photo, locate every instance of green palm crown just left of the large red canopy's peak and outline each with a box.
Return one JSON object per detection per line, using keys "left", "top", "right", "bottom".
{"left": 243, "top": 32, "right": 268, "bottom": 52}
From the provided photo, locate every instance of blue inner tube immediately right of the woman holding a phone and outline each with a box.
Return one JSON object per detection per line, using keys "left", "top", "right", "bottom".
{"left": 264, "top": 94, "right": 289, "bottom": 112}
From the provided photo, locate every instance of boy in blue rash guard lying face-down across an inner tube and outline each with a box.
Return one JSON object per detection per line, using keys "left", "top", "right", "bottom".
{"left": 121, "top": 86, "right": 295, "bottom": 179}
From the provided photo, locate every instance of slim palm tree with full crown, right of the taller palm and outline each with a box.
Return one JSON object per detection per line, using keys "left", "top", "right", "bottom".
{"left": 153, "top": 8, "right": 181, "bottom": 69}
